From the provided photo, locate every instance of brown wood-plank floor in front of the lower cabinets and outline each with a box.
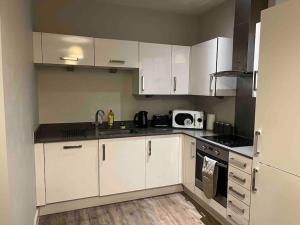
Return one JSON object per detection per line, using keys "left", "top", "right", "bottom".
{"left": 39, "top": 194, "right": 219, "bottom": 225}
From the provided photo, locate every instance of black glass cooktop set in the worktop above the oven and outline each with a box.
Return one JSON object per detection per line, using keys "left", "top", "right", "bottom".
{"left": 203, "top": 135, "right": 253, "bottom": 148}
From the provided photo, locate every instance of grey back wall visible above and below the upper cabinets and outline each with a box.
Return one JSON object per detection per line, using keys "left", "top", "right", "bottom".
{"left": 34, "top": 0, "right": 234, "bottom": 123}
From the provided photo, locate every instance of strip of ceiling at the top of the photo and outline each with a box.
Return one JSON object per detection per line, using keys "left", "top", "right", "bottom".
{"left": 98, "top": 0, "right": 228, "bottom": 15}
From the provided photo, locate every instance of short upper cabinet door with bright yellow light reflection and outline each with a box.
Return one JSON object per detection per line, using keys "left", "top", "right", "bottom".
{"left": 42, "top": 33, "right": 94, "bottom": 66}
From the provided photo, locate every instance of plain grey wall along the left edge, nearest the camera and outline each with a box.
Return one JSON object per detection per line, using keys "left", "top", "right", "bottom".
{"left": 0, "top": 0, "right": 38, "bottom": 225}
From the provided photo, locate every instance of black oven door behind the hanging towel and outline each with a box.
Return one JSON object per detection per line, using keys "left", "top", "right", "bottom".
{"left": 195, "top": 149, "right": 228, "bottom": 208}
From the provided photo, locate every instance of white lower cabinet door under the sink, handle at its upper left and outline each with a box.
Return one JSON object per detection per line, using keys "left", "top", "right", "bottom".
{"left": 99, "top": 137, "right": 146, "bottom": 196}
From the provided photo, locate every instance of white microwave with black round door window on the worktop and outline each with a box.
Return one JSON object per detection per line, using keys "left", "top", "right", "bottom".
{"left": 172, "top": 110, "right": 204, "bottom": 129}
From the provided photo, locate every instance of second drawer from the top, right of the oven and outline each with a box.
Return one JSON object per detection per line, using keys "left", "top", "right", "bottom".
{"left": 228, "top": 166, "right": 251, "bottom": 190}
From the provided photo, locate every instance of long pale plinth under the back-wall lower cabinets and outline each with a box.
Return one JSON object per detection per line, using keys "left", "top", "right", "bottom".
{"left": 39, "top": 184, "right": 183, "bottom": 216}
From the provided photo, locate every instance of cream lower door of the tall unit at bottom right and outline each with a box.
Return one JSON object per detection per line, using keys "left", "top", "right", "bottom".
{"left": 250, "top": 164, "right": 300, "bottom": 225}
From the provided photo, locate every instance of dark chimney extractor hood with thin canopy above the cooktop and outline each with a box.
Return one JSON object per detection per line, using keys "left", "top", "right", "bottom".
{"left": 211, "top": 0, "right": 268, "bottom": 78}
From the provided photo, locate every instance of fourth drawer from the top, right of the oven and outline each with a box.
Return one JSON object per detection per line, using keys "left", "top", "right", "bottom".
{"left": 227, "top": 194, "right": 250, "bottom": 221}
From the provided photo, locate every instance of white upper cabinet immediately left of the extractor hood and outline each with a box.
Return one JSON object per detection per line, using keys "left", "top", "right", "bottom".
{"left": 190, "top": 37, "right": 236, "bottom": 96}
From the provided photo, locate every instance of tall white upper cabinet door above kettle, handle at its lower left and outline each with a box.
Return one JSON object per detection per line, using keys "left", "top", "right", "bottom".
{"left": 139, "top": 43, "right": 172, "bottom": 95}
